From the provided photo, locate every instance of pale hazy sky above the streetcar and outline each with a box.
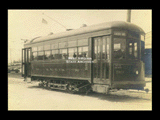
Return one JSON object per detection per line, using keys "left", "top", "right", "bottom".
{"left": 8, "top": 9, "right": 152, "bottom": 63}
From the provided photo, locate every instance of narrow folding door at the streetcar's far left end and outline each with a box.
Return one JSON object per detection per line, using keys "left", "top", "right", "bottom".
{"left": 22, "top": 48, "right": 31, "bottom": 77}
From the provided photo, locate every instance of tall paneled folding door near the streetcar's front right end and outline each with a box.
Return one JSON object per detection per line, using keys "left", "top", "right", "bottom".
{"left": 93, "top": 36, "right": 110, "bottom": 83}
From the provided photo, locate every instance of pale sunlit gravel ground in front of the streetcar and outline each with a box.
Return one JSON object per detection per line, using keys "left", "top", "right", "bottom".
{"left": 8, "top": 73, "right": 152, "bottom": 110}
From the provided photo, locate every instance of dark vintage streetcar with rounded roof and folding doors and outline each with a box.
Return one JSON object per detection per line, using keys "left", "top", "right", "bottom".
{"left": 22, "top": 21, "right": 146, "bottom": 93}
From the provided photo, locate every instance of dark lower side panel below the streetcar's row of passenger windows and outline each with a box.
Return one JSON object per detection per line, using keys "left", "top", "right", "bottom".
{"left": 31, "top": 62, "right": 91, "bottom": 80}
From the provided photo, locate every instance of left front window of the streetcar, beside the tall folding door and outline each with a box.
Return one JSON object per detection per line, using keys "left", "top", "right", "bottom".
{"left": 113, "top": 38, "right": 126, "bottom": 59}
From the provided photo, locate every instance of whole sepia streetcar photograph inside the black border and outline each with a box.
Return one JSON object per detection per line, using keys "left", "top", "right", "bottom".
{"left": 7, "top": 9, "right": 152, "bottom": 111}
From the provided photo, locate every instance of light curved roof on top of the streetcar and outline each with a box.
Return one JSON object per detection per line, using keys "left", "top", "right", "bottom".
{"left": 26, "top": 21, "right": 144, "bottom": 43}
